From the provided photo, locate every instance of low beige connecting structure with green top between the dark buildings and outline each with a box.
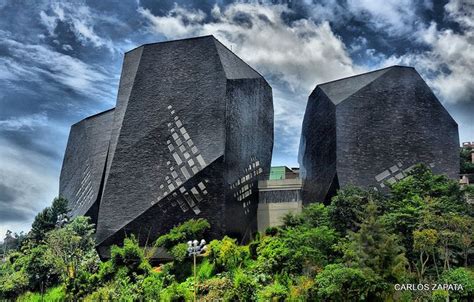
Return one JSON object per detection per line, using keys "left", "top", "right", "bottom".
{"left": 257, "top": 166, "right": 302, "bottom": 232}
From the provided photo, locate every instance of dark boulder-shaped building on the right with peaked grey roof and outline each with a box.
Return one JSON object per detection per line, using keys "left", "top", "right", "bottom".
{"left": 299, "top": 66, "right": 459, "bottom": 204}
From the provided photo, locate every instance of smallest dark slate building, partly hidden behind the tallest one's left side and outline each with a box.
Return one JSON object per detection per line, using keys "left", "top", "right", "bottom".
{"left": 59, "top": 109, "right": 114, "bottom": 223}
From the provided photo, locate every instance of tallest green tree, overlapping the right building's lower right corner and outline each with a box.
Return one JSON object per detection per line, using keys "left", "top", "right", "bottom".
{"left": 382, "top": 165, "right": 474, "bottom": 262}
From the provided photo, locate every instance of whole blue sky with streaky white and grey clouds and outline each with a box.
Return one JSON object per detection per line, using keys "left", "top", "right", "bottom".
{"left": 0, "top": 0, "right": 474, "bottom": 237}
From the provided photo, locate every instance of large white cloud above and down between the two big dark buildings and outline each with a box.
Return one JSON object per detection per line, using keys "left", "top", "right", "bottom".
{"left": 138, "top": 3, "right": 361, "bottom": 158}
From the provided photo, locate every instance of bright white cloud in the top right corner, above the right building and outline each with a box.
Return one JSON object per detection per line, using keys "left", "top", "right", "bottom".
{"left": 383, "top": 0, "right": 474, "bottom": 103}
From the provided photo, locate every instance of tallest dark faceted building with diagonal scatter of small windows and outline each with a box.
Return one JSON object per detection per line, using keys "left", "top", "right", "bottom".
{"left": 60, "top": 36, "right": 273, "bottom": 257}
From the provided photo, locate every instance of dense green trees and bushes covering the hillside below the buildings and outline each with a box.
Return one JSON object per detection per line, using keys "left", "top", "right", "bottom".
{"left": 0, "top": 166, "right": 474, "bottom": 301}
